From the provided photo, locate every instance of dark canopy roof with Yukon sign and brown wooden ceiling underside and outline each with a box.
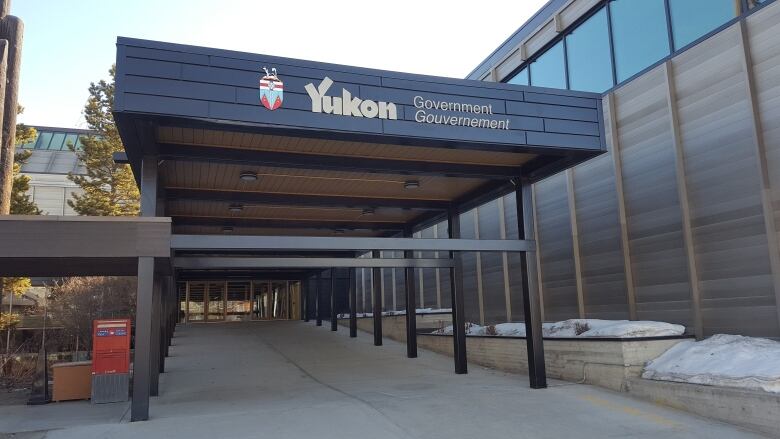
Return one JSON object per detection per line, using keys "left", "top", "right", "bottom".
{"left": 114, "top": 37, "right": 606, "bottom": 236}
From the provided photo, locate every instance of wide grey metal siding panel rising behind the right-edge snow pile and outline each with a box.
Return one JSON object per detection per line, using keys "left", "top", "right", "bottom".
{"left": 673, "top": 26, "right": 778, "bottom": 336}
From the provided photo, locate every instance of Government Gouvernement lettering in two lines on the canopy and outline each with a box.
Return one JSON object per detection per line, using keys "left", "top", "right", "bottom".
{"left": 413, "top": 96, "right": 509, "bottom": 130}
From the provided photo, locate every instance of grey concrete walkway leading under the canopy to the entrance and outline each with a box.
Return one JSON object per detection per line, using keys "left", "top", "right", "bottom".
{"left": 0, "top": 322, "right": 760, "bottom": 439}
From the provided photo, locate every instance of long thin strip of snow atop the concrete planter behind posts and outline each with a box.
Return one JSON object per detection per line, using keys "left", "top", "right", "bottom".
{"left": 434, "top": 319, "right": 685, "bottom": 338}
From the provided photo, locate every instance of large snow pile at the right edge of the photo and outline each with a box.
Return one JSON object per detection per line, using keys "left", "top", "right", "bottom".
{"left": 642, "top": 334, "right": 780, "bottom": 393}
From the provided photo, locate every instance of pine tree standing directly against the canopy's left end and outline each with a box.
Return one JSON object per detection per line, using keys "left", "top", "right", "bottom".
{"left": 68, "top": 66, "right": 140, "bottom": 216}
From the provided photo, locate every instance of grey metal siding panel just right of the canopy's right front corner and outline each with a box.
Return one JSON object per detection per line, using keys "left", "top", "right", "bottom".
{"left": 615, "top": 64, "right": 691, "bottom": 325}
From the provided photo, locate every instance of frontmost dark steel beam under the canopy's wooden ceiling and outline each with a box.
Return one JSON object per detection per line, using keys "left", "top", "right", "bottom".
{"left": 158, "top": 143, "right": 520, "bottom": 180}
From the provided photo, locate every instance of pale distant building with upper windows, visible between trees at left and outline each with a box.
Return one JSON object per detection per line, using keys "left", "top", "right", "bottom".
{"left": 17, "top": 126, "right": 91, "bottom": 215}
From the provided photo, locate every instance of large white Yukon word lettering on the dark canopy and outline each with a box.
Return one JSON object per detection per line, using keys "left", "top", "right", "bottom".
{"left": 305, "top": 76, "right": 398, "bottom": 120}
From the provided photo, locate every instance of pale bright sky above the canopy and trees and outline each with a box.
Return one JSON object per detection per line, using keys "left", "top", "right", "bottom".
{"left": 11, "top": 0, "right": 546, "bottom": 127}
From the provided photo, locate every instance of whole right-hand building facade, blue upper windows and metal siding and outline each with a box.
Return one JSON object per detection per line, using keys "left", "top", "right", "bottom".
{"left": 400, "top": 0, "right": 780, "bottom": 338}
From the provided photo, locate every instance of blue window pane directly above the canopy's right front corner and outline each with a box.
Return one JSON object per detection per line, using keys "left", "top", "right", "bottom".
{"left": 566, "top": 8, "right": 614, "bottom": 93}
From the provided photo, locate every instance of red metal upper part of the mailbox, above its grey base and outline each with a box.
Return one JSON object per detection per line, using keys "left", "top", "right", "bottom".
{"left": 92, "top": 319, "right": 130, "bottom": 375}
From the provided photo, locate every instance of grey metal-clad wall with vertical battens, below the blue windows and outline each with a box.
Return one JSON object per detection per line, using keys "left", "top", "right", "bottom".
{"left": 358, "top": 3, "right": 780, "bottom": 337}
